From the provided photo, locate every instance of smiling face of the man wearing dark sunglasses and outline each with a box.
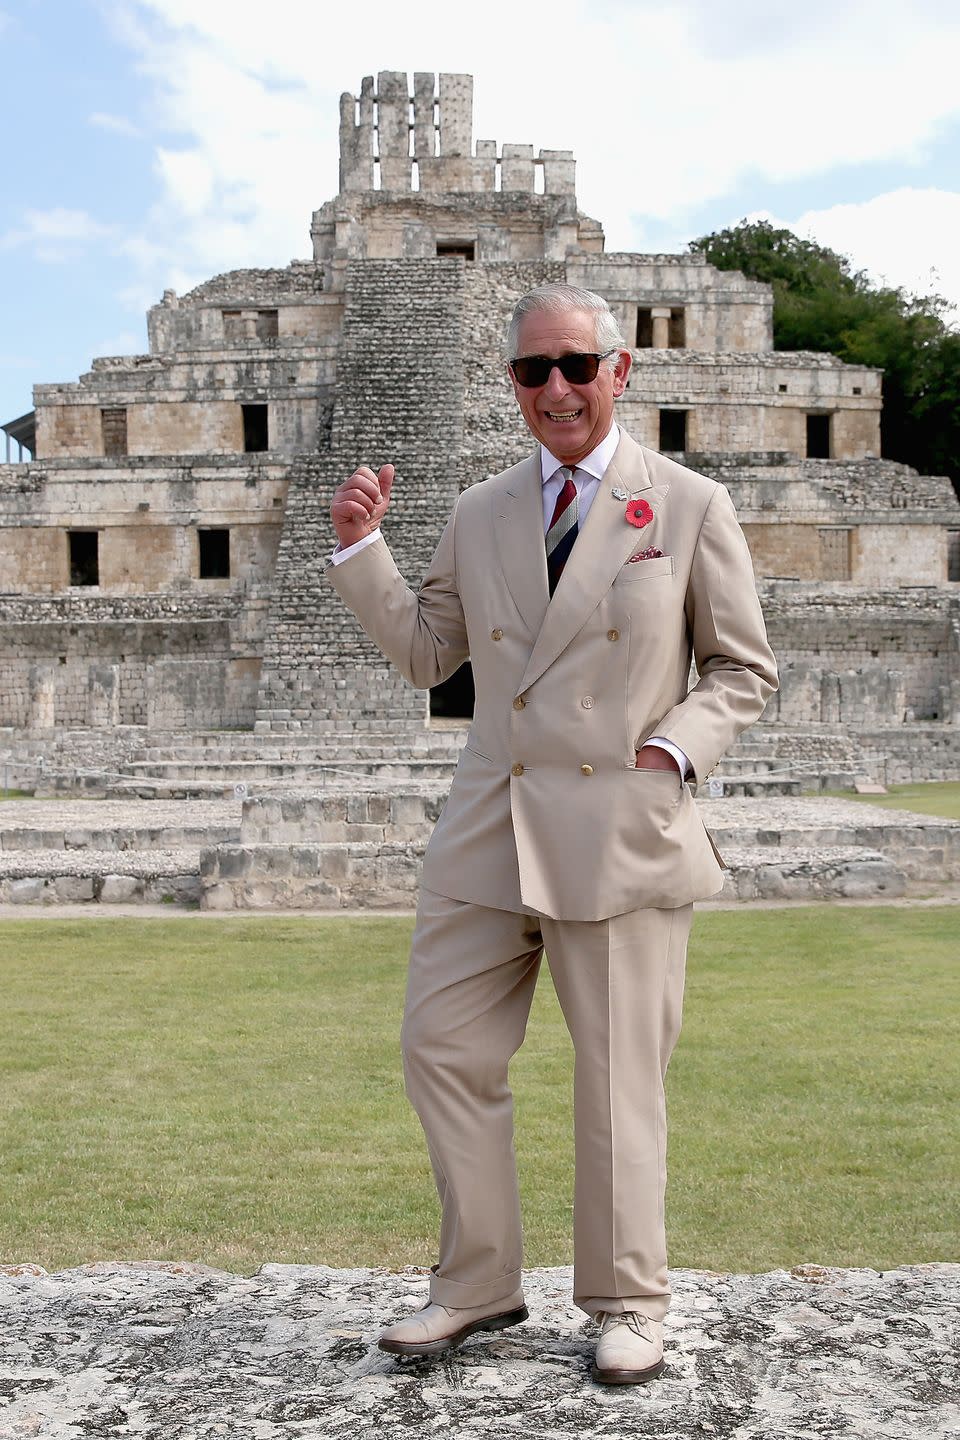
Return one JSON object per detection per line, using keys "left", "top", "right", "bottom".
{"left": 510, "top": 310, "right": 630, "bottom": 465}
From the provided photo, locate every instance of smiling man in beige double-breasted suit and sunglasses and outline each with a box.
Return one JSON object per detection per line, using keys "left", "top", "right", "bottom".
{"left": 328, "top": 285, "right": 776, "bottom": 1384}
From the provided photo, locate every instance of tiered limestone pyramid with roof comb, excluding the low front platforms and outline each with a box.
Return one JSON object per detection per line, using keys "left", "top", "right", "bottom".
{"left": 0, "top": 72, "right": 960, "bottom": 778}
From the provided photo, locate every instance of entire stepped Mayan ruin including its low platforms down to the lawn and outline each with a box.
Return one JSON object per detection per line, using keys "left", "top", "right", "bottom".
{"left": 0, "top": 71, "right": 960, "bottom": 907}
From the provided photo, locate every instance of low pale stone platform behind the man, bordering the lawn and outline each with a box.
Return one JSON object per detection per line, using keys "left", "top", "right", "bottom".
{"left": 0, "top": 775, "right": 960, "bottom": 910}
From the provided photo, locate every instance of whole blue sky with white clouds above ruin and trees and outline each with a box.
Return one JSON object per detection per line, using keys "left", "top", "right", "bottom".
{"left": 0, "top": 0, "right": 960, "bottom": 429}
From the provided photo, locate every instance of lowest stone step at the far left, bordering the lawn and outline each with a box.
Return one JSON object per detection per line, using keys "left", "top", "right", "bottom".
{"left": 0, "top": 848, "right": 200, "bottom": 904}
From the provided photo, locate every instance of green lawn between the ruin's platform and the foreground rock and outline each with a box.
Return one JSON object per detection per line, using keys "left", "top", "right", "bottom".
{"left": 0, "top": 907, "right": 960, "bottom": 1270}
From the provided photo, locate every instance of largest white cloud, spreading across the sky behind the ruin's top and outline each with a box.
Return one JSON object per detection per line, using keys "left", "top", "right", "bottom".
{"left": 43, "top": 0, "right": 960, "bottom": 321}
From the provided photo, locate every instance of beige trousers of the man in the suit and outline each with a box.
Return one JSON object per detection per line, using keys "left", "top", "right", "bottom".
{"left": 403, "top": 890, "right": 692, "bottom": 1319}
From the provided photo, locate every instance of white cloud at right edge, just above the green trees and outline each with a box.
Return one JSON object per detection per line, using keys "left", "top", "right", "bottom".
{"left": 748, "top": 187, "right": 960, "bottom": 318}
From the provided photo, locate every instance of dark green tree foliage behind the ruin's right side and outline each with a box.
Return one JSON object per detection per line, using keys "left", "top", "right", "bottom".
{"left": 689, "top": 220, "right": 960, "bottom": 494}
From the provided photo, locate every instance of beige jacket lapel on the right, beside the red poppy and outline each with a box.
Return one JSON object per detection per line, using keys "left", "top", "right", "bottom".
{"left": 511, "top": 433, "right": 669, "bottom": 694}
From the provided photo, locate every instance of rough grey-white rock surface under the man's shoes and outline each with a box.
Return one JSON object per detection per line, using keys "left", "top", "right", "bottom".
{"left": 0, "top": 1264, "right": 960, "bottom": 1440}
